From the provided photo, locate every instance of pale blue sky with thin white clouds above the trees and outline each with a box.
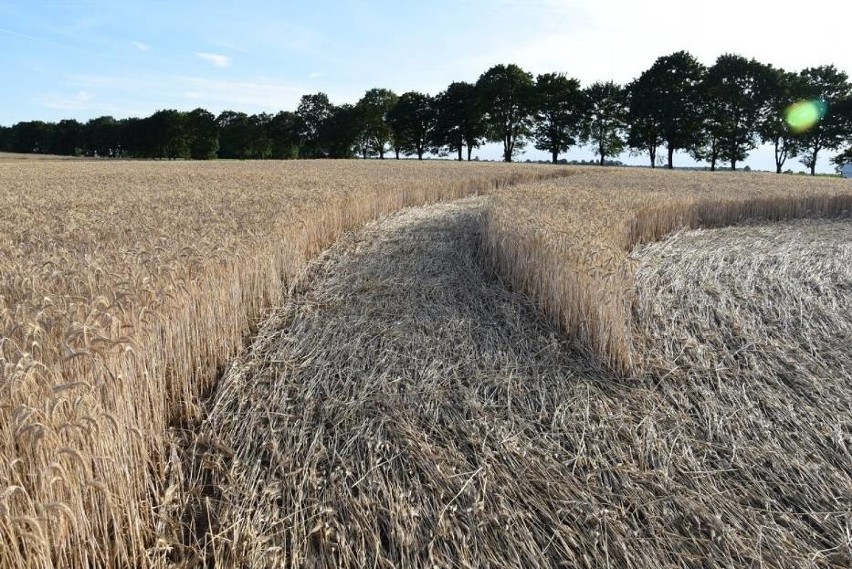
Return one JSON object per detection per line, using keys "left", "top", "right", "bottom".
{"left": 0, "top": 0, "right": 852, "bottom": 168}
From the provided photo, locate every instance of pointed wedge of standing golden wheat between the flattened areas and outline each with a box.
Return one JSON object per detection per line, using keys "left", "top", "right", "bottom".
{"left": 483, "top": 168, "right": 852, "bottom": 375}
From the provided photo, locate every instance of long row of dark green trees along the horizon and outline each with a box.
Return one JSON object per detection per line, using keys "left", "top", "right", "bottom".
{"left": 5, "top": 51, "right": 852, "bottom": 174}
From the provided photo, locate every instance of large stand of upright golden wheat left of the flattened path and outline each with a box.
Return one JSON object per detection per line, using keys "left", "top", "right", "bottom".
{"left": 0, "top": 160, "right": 564, "bottom": 567}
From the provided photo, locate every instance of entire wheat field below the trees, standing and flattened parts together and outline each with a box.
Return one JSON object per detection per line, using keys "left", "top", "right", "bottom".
{"left": 0, "top": 161, "right": 852, "bottom": 567}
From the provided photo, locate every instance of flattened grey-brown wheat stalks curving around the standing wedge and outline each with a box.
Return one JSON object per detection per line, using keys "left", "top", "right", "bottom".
{"left": 173, "top": 196, "right": 852, "bottom": 569}
